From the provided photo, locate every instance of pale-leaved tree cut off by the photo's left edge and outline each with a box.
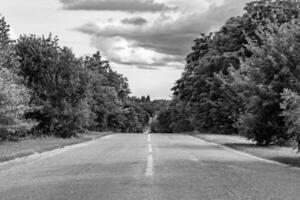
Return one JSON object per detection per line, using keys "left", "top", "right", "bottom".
{"left": 0, "top": 15, "right": 30, "bottom": 140}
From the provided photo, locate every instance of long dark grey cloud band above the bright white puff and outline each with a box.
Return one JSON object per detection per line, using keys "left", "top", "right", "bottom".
{"left": 77, "top": 0, "right": 249, "bottom": 68}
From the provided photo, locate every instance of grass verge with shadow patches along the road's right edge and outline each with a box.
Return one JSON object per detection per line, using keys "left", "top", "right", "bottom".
{"left": 195, "top": 134, "right": 300, "bottom": 167}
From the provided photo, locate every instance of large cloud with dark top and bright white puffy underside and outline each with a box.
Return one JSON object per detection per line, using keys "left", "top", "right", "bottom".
{"left": 77, "top": 0, "right": 249, "bottom": 67}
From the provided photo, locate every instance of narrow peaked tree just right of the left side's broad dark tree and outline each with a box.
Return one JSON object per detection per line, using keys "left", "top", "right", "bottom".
{"left": 83, "top": 52, "right": 123, "bottom": 131}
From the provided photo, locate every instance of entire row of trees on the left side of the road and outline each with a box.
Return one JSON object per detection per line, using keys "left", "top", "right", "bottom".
{"left": 0, "top": 17, "right": 164, "bottom": 141}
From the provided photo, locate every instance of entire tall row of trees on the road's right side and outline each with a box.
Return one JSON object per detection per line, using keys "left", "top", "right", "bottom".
{"left": 152, "top": 0, "right": 300, "bottom": 150}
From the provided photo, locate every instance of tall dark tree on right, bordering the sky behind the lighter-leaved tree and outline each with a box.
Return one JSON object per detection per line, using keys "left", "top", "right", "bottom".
{"left": 173, "top": 0, "right": 299, "bottom": 138}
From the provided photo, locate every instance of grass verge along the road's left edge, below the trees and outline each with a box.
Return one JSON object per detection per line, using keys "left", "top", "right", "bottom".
{"left": 0, "top": 132, "right": 111, "bottom": 162}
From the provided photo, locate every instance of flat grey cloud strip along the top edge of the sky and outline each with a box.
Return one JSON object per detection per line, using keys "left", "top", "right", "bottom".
{"left": 60, "top": 0, "right": 176, "bottom": 12}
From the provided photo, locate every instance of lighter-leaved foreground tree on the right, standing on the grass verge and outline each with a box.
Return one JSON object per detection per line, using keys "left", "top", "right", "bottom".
{"left": 233, "top": 22, "right": 300, "bottom": 144}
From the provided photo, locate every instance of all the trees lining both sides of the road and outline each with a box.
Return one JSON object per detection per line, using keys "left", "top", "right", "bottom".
{"left": 0, "top": 0, "right": 300, "bottom": 164}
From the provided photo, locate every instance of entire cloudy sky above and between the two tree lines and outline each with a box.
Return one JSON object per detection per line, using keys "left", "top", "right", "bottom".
{"left": 0, "top": 0, "right": 249, "bottom": 99}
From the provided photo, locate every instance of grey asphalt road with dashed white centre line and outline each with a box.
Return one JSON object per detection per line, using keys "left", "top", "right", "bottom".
{"left": 0, "top": 134, "right": 300, "bottom": 200}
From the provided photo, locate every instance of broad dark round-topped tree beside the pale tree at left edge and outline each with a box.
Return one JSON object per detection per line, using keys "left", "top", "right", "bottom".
{"left": 16, "top": 35, "right": 87, "bottom": 137}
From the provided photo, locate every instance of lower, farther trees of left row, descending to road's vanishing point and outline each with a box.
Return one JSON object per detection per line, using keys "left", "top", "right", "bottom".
{"left": 83, "top": 52, "right": 151, "bottom": 133}
